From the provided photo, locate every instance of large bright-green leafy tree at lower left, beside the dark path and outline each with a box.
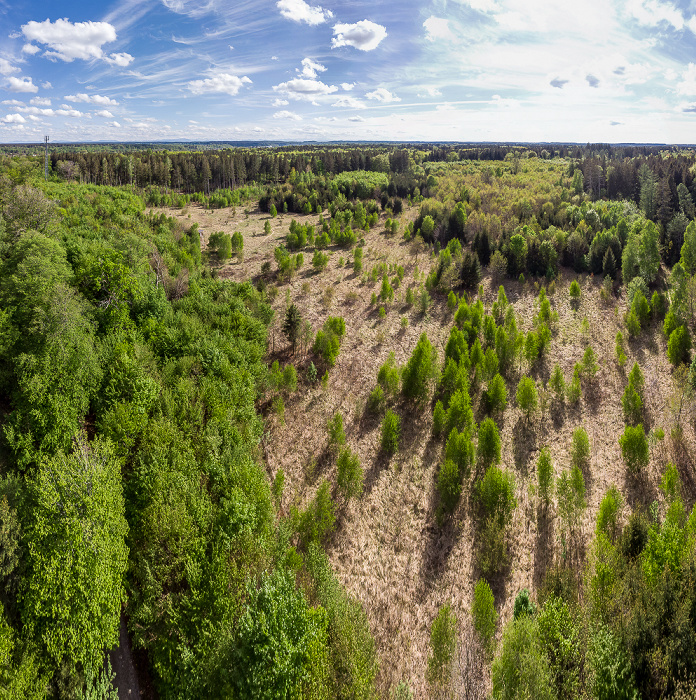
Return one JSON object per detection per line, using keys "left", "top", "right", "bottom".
{"left": 22, "top": 436, "right": 128, "bottom": 666}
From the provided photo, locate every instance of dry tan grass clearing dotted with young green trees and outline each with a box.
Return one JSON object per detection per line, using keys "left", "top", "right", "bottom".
{"left": 159, "top": 200, "right": 696, "bottom": 697}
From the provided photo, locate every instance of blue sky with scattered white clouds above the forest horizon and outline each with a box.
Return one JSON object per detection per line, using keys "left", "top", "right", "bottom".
{"left": 0, "top": 0, "right": 696, "bottom": 143}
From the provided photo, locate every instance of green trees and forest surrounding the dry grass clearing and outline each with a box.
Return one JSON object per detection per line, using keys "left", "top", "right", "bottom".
{"left": 0, "top": 145, "right": 696, "bottom": 700}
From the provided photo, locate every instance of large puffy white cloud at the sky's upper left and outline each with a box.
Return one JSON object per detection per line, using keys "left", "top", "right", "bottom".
{"left": 22, "top": 19, "right": 118, "bottom": 63}
